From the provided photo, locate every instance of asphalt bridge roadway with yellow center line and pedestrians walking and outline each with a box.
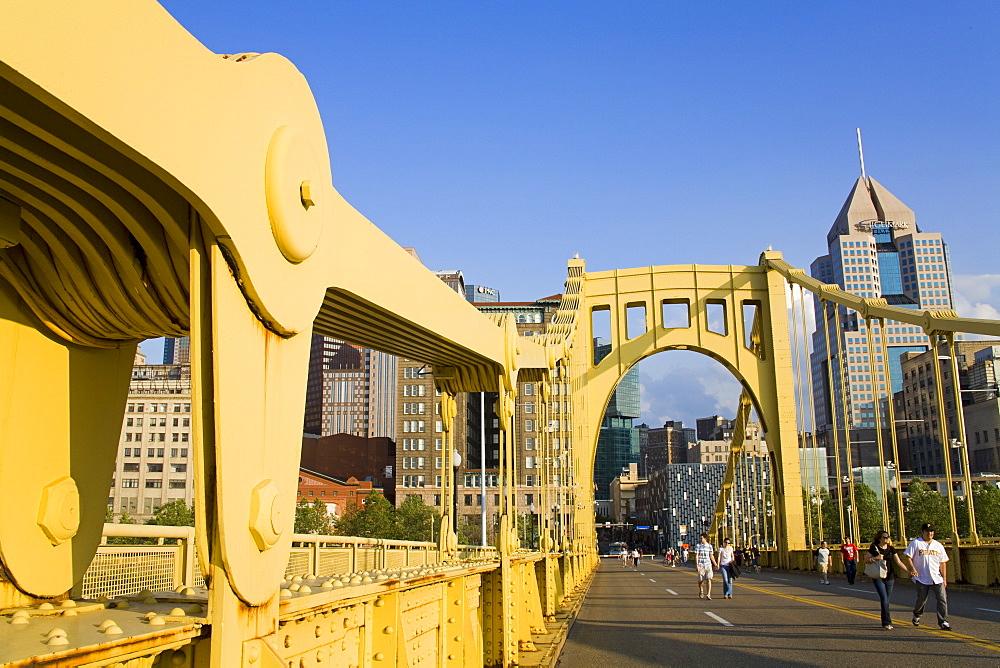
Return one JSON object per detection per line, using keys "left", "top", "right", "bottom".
{"left": 558, "top": 558, "right": 1000, "bottom": 668}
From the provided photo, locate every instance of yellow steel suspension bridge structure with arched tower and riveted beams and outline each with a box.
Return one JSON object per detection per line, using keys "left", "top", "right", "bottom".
{"left": 0, "top": 0, "right": 1000, "bottom": 666}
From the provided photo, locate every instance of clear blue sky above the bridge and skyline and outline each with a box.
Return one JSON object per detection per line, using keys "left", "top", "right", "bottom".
{"left": 145, "top": 0, "right": 1000, "bottom": 422}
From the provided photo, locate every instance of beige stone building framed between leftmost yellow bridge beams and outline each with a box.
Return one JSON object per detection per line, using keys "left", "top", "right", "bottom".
{"left": 108, "top": 353, "right": 194, "bottom": 521}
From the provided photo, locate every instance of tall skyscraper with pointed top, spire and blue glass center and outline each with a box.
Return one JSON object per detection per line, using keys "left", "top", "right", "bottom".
{"left": 811, "top": 176, "right": 952, "bottom": 465}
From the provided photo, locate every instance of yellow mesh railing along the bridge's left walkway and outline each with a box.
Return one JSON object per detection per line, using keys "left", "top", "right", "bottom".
{"left": 80, "top": 524, "right": 498, "bottom": 598}
